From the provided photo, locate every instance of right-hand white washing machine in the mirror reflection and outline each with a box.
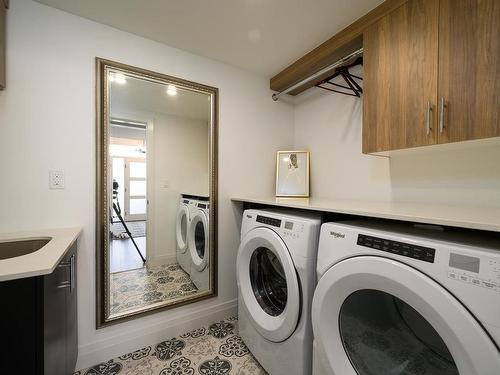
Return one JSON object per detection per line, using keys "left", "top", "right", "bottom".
{"left": 187, "top": 200, "right": 210, "bottom": 291}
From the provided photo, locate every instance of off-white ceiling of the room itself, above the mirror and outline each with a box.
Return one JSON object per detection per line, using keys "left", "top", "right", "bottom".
{"left": 35, "top": 0, "right": 382, "bottom": 77}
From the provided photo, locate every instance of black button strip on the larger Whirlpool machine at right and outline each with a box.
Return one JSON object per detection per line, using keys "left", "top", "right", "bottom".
{"left": 357, "top": 234, "right": 436, "bottom": 263}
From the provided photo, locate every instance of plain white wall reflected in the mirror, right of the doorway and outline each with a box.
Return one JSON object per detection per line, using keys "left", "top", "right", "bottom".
{"left": 152, "top": 115, "right": 209, "bottom": 264}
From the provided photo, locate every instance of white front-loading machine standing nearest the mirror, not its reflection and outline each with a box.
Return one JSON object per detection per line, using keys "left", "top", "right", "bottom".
{"left": 236, "top": 210, "right": 321, "bottom": 375}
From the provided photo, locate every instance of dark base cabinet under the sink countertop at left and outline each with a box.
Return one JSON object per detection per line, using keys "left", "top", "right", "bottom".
{"left": 0, "top": 243, "right": 78, "bottom": 375}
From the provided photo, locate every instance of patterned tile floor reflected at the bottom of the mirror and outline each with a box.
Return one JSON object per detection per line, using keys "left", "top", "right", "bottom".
{"left": 110, "top": 263, "right": 198, "bottom": 314}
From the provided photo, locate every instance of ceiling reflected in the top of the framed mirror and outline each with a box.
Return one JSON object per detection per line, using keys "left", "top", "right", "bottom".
{"left": 110, "top": 76, "right": 210, "bottom": 123}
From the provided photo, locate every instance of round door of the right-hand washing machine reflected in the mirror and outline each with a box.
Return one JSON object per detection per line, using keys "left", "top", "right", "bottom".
{"left": 188, "top": 210, "right": 210, "bottom": 272}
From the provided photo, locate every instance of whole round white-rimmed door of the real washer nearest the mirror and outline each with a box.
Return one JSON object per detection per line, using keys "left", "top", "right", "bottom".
{"left": 236, "top": 228, "right": 301, "bottom": 342}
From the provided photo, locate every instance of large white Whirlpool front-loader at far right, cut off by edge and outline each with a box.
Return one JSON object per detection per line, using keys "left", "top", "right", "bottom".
{"left": 312, "top": 222, "right": 500, "bottom": 375}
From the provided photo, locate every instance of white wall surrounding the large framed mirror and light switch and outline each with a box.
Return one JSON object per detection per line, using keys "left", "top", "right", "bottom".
{"left": 0, "top": 0, "right": 293, "bottom": 366}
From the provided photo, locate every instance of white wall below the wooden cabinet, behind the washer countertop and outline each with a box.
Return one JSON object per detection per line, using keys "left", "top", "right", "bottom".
{"left": 294, "top": 75, "right": 500, "bottom": 207}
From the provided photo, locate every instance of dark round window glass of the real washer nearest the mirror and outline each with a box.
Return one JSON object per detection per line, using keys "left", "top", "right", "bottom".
{"left": 249, "top": 247, "right": 288, "bottom": 316}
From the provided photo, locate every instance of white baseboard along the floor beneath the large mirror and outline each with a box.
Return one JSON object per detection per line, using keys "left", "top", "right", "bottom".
{"left": 76, "top": 299, "right": 238, "bottom": 369}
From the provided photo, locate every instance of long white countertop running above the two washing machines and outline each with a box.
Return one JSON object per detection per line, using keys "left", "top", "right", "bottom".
{"left": 231, "top": 197, "right": 500, "bottom": 232}
